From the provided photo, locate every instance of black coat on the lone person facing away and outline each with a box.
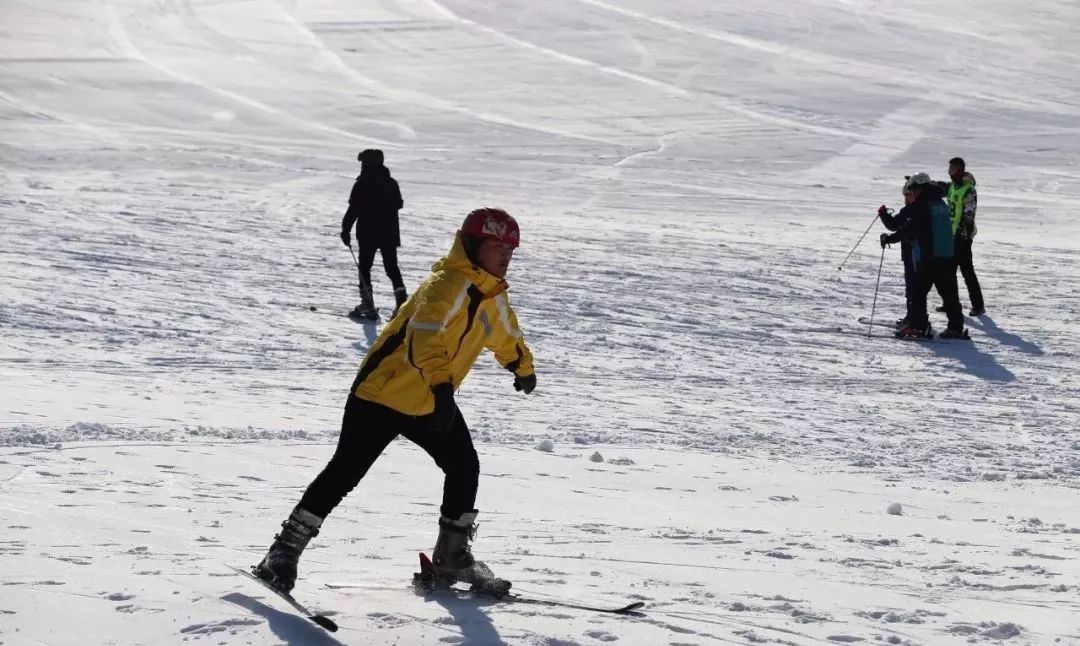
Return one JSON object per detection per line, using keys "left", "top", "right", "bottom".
{"left": 341, "top": 163, "right": 404, "bottom": 248}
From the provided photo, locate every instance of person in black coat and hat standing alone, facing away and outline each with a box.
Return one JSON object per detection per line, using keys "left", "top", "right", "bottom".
{"left": 341, "top": 148, "right": 408, "bottom": 320}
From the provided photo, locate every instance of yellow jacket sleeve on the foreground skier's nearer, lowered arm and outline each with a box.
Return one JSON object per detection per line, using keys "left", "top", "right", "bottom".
{"left": 406, "top": 272, "right": 469, "bottom": 386}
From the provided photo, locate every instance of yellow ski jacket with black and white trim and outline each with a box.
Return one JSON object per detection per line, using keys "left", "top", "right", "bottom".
{"left": 353, "top": 233, "right": 532, "bottom": 415}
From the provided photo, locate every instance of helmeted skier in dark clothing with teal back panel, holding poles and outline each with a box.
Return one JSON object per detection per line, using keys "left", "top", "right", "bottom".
{"left": 881, "top": 173, "right": 967, "bottom": 338}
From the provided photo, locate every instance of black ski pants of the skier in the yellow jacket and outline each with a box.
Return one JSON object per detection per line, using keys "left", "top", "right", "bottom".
{"left": 300, "top": 393, "right": 480, "bottom": 527}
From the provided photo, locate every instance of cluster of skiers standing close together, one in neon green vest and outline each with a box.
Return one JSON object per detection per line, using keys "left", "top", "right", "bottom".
{"left": 878, "top": 157, "right": 986, "bottom": 338}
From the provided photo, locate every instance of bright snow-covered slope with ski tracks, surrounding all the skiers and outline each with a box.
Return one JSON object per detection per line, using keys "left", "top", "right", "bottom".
{"left": 0, "top": 0, "right": 1080, "bottom": 646}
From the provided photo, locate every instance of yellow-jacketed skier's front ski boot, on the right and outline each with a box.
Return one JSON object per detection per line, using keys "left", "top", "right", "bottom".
{"left": 431, "top": 509, "right": 511, "bottom": 598}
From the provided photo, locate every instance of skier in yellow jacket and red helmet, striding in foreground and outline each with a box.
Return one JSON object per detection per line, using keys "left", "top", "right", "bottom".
{"left": 253, "top": 207, "right": 537, "bottom": 594}
